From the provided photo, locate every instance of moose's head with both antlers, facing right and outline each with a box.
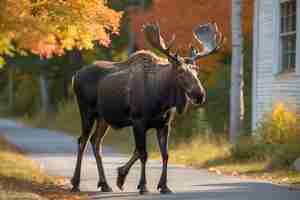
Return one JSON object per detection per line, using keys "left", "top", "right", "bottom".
{"left": 143, "top": 23, "right": 224, "bottom": 108}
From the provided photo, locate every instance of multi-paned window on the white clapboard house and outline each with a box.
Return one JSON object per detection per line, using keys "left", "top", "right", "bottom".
{"left": 280, "top": 0, "right": 297, "bottom": 72}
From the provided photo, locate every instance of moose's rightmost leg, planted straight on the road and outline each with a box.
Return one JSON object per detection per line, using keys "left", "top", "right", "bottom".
{"left": 157, "top": 125, "right": 172, "bottom": 194}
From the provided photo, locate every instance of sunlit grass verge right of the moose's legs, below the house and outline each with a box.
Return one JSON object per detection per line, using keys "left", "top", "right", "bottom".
{"left": 161, "top": 136, "right": 300, "bottom": 186}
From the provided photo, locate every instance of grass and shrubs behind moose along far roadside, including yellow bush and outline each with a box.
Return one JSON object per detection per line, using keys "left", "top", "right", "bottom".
{"left": 23, "top": 99, "right": 300, "bottom": 187}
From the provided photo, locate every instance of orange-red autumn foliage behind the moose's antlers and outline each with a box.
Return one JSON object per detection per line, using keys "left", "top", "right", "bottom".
{"left": 130, "top": 0, "right": 254, "bottom": 71}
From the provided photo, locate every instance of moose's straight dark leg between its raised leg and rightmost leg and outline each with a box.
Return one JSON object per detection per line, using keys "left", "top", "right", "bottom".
{"left": 133, "top": 122, "right": 148, "bottom": 194}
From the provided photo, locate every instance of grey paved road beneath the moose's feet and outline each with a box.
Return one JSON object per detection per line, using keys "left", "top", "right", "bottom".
{"left": 0, "top": 120, "right": 300, "bottom": 200}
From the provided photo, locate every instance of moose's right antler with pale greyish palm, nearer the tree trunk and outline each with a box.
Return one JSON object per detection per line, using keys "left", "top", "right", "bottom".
{"left": 188, "top": 23, "right": 225, "bottom": 62}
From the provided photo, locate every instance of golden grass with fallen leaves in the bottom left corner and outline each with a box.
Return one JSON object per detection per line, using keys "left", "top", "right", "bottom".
{"left": 0, "top": 134, "right": 85, "bottom": 200}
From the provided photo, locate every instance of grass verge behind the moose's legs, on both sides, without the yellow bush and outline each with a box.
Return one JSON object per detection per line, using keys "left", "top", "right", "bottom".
{"left": 23, "top": 103, "right": 300, "bottom": 188}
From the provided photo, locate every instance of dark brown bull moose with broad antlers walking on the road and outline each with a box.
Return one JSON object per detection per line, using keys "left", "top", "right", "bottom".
{"left": 71, "top": 23, "right": 223, "bottom": 194}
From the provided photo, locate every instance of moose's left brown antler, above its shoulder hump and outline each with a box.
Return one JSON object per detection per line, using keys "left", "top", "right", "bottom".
{"left": 143, "top": 23, "right": 176, "bottom": 59}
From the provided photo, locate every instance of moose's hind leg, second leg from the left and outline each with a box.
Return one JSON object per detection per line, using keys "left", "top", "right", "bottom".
{"left": 91, "top": 120, "right": 112, "bottom": 192}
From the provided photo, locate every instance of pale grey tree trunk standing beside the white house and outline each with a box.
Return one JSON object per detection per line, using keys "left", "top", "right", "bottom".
{"left": 230, "top": 0, "right": 244, "bottom": 144}
